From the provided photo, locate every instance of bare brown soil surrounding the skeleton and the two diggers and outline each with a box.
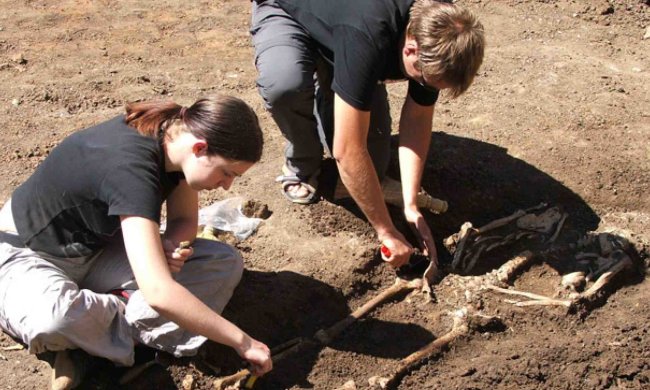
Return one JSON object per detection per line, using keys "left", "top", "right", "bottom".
{"left": 0, "top": 0, "right": 650, "bottom": 389}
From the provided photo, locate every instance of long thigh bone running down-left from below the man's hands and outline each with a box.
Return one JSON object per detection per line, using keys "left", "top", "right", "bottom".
{"left": 314, "top": 278, "right": 422, "bottom": 345}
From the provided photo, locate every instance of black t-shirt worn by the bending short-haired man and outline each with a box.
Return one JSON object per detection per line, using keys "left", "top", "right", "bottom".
{"left": 277, "top": 0, "right": 438, "bottom": 111}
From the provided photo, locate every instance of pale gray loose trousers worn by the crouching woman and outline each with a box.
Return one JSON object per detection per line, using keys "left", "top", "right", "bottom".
{"left": 0, "top": 202, "right": 243, "bottom": 366}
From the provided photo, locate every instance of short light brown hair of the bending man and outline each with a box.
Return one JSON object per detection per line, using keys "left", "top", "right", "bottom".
{"left": 406, "top": 0, "right": 485, "bottom": 97}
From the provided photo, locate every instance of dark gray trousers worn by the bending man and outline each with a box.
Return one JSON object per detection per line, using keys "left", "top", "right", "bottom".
{"left": 251, "top": 0, "right": 391, "bottom": 179}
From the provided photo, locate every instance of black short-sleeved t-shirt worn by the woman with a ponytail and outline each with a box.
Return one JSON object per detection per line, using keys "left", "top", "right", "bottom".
{"left": 11, "top": 116, "right": 182, "bottom": 257}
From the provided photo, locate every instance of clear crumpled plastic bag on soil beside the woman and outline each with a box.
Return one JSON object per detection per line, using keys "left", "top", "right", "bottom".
{"left": 199, "top": 197, "right": 262, "bottom": 240}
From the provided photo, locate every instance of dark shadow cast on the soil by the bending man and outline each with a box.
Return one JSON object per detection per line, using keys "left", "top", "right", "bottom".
{"left": 323, "top": 132, "right": 600, "bottom": 266}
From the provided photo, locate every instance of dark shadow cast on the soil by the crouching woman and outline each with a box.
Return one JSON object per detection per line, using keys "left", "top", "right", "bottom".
{"left": 74, "top": 270, "right": 435, "bottom": 390}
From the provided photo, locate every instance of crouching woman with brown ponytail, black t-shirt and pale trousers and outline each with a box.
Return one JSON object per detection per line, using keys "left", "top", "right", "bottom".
{"left": 0, "top": 96, "right": 272, "bottom": 388}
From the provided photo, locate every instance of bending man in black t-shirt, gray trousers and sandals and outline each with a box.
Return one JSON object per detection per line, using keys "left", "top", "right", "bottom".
{"left": 251, "top": 0, "right": 484, "bottom": 267}
